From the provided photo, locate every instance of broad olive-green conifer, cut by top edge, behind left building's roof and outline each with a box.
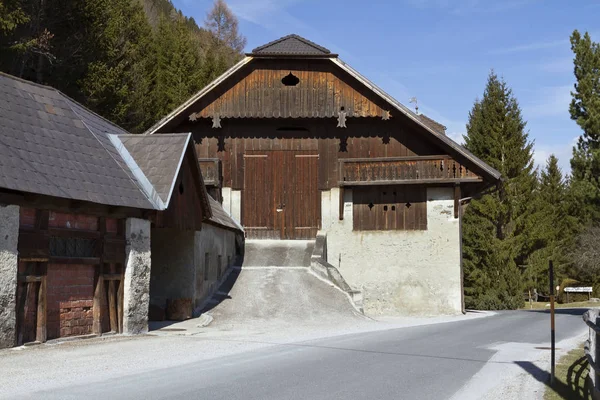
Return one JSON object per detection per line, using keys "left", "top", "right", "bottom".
{"left": 80, "top": 0, "right": 155, "bottom": 132}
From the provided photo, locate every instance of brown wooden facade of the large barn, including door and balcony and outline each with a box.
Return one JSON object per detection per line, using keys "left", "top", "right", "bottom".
{"left": 155, "top": 54, "right": 496, "bottom": 239}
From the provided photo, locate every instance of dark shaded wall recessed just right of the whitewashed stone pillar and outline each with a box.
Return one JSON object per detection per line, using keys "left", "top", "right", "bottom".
{"left": 150, "top": 229, "right": 196, "bottom": 309}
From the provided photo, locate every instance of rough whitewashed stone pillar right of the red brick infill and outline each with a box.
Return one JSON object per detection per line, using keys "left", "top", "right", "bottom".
{"left": 123, "top": 218, "right": 151, "bottom": 334}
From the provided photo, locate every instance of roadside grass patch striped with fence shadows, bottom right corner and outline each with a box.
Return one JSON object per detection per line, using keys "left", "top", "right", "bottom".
{"left": 544, "top": 344, "right": 592, "bottom": 400}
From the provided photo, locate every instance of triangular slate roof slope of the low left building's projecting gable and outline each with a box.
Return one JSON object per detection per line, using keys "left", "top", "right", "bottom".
{"left": 119, "top": 133, "right": 190, "bottom": 205}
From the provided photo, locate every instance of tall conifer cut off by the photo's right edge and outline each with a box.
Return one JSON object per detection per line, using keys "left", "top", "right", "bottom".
{"left": 569, "top": 30, "right": 600, "bottom": 224}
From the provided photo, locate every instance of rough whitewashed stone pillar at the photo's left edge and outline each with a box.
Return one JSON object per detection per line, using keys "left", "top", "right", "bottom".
{"left": 0, "top": 204, "right": 19, "bottom": 348}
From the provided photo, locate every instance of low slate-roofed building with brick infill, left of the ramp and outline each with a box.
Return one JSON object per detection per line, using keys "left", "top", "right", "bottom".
{"left": 0, "top": 74, "right": 243, "bottom": 347}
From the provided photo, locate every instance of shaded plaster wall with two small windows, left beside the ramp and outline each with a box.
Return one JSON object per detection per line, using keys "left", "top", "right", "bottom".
{"left": 194, "top": 224, "right": 242, "bottom": 315}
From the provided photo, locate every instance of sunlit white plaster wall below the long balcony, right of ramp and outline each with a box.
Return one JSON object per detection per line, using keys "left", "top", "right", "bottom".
{"left": 321, "top": 187, "right": 462, "bottom": 315}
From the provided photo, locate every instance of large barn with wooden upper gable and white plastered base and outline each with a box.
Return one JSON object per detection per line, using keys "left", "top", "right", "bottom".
{"left": 148, "top": 35, "right": 500, "bottom": 314}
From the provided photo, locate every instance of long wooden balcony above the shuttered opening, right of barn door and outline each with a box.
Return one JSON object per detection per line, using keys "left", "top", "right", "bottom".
{"left": 339, "top": 156, "right": 482, "bottom": 186}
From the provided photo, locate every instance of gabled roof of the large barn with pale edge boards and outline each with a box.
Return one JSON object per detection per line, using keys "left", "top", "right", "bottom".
{"left": 146, "top": 35, "right": 501, "bottom": 180}
